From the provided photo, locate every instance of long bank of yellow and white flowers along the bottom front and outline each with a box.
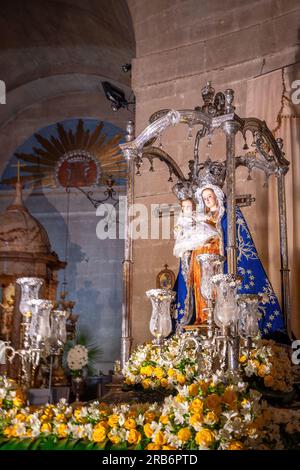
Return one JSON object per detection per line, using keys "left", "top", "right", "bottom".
{"left": 0, "top": 370, "right": 300, "bottom": 451}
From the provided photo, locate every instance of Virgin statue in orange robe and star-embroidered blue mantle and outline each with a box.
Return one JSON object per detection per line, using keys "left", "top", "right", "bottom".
{"left": 174, "top": 177, "right": 285, "bottom": 337}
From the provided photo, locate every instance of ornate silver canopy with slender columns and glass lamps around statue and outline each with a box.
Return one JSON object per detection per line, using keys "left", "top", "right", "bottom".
{"left": 120, "top": 82, "right": 291, "bottom": 370}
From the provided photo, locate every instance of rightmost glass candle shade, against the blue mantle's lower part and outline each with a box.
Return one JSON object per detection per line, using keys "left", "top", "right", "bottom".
{"left": 238, "top": 294, "right": 260, "bottom": 340}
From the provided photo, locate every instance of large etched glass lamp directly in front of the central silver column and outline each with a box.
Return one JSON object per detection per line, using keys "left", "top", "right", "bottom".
{"left": 211, "top": 274, "right": 241, "bottom": 329}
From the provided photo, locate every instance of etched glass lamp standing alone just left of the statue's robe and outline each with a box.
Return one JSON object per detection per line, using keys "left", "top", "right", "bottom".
{"left": 146, "top": 289, "right": 176, "bottom": 344}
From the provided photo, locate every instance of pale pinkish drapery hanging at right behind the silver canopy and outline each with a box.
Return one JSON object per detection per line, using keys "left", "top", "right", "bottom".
{"left": 246, "top": 66, "right": 300, "bottom": 337}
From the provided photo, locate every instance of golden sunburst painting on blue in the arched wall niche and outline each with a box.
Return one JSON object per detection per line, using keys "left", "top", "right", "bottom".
{"left": 1, "top": 119, "right": 127, "bottom": 188}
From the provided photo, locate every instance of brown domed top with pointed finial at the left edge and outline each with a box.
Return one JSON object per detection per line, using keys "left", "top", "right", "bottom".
{"left": 0, "top": 183, "right": 51, "bottom": 254}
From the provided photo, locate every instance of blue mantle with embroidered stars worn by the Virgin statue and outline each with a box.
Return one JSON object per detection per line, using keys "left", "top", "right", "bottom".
{"left": 174, "top": 207, "right": 285, "bottom": 337}
